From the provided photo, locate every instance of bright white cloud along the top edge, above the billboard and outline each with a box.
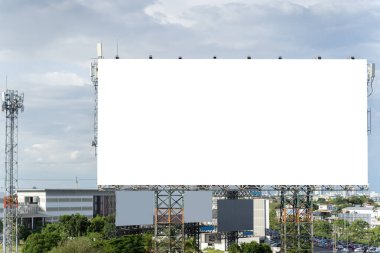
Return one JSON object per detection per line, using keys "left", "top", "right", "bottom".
{"left": 144, "top": 0, "right": 380, "bottom": 29}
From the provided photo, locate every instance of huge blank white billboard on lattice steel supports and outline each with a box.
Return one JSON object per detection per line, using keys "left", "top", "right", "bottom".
{"left": 97, "top": 59, "right": 368, "bottom": 185}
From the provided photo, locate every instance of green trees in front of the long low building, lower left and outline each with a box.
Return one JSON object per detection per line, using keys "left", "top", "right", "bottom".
{"left": 19, "top": 214, "right": 152, "bottom": 253}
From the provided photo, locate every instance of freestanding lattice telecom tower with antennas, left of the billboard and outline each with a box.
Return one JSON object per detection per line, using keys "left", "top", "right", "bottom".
{"left": 2, "top": 90, "right": 24, "bottom": 253}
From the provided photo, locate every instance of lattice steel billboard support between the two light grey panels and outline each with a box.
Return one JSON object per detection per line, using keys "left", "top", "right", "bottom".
{"left": 154, "top": 187, "right": 185, "bottom": 253}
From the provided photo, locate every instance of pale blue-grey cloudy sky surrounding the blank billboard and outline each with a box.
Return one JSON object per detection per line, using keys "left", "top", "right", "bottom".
{"left": 0, "top": 0, "right": 380, "bottom": 192}
